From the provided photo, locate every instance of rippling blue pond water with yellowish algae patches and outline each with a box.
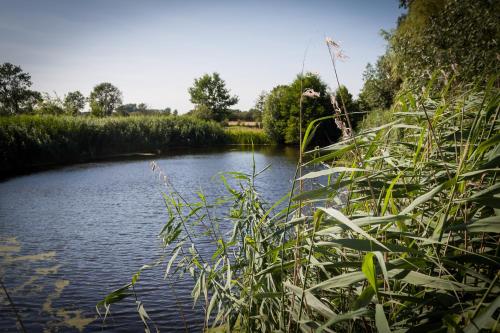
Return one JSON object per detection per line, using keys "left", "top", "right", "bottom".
{"left": 0, "top": 148, "right": 296, "bottom": 332}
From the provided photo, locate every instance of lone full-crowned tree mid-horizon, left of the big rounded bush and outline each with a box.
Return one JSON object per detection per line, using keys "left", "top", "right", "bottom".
{"left": 189, "top": 73, "right": 238, "bottom": 121}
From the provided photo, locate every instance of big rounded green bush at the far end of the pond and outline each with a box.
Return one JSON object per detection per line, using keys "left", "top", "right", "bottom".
{"left": 263, "top": 73, "right": 339, "bottom": 144}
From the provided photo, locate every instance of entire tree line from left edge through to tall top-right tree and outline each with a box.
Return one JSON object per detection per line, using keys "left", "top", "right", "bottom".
{"left": 0, "top": 0, "right": 500, "bottom": 144}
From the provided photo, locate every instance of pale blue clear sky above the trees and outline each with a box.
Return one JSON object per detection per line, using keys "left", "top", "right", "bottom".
{"left": 0, "top": 0, "right": 402, "bottom": 113}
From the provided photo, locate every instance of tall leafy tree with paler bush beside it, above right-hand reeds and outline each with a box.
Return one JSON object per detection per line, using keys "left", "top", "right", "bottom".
{"left": 359, "top": 0, "right": 500, "bottom": 111}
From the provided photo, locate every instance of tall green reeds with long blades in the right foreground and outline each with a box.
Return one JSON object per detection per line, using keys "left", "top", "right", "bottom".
{"left": 100, "top": 78, "right": 500, "bottom": 332}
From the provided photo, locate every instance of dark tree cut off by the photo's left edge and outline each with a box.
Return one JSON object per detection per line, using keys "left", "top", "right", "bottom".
{"left": 0, "top": 62, "right": 41, "bottom": 115}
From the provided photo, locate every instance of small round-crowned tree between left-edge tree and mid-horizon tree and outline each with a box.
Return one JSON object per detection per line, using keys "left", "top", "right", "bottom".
{"left": 89, "top": 82, "right": 122, "bottom": 117}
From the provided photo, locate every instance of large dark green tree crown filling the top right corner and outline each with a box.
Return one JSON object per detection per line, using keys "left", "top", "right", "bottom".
{"left": 390, "top": 0, "right": 500, "bottom": 89}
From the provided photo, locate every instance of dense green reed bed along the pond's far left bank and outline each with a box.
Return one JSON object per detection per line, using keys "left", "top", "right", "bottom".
{"left": 0, "top": 116, "right": 267, "bottom": 177}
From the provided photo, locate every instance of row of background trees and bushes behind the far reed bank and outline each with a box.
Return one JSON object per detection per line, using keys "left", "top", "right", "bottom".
{"left": 0, "top": 63, "right": 359, "bottom": 144}
